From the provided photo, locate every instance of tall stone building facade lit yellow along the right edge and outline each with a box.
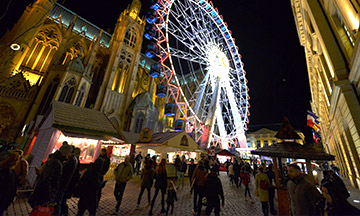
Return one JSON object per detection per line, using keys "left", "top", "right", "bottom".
{"left": 291, "top": 0, "right": 360, "bottom": 187}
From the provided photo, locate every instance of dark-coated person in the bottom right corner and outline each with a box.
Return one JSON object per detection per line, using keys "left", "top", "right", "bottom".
{"left": 321, "top": 178, "right": 360, "bottom": 216}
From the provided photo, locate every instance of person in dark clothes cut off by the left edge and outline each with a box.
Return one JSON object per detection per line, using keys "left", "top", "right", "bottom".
{"left": 0, "top": 150, "right": 20, "bottom": 215}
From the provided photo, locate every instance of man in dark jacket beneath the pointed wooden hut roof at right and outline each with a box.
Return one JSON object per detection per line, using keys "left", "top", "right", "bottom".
{"left": 288, "top": 164, "right": 321, "bottom": 216}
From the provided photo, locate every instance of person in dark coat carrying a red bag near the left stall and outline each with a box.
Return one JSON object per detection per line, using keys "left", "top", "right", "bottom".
{"left": 28, "top": 144, "right": 73, "bottom": 209}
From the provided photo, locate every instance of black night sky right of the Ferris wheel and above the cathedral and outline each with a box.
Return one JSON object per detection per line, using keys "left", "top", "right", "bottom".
{"left": 0, "top": 0, "right": 312, "bottom": 142}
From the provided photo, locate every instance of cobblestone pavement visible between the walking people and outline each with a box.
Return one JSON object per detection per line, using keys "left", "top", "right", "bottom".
{"left": 4, "top": 172, "right": 262, "bottom": 216}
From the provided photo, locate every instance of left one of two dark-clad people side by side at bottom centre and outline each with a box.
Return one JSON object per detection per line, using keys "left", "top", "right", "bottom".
{"left": 193, "top": 161, "right": 207, "bottom": 215}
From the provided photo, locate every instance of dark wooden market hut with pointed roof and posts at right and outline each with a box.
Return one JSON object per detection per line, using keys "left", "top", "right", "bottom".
{"left": 251, "top": 118, "right": 334, "bottom": 215}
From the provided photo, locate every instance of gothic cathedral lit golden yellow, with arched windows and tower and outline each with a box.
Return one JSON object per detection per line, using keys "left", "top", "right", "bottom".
{"left": 0, "top": 0, "right": 166, "bottom": 145}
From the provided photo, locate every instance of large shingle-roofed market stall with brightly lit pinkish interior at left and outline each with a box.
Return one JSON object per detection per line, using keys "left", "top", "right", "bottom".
{"left": 29, "top": 101, "right": 125, "bottom": 185}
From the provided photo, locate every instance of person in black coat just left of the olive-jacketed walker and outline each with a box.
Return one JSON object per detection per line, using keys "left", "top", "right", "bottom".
{"left": 77, "top": 158, "right": 104, "bottom": 216}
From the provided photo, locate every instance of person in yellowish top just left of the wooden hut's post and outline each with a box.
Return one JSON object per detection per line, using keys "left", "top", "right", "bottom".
{"left": 255, "top": 167, "right": 270, "bottom": 216}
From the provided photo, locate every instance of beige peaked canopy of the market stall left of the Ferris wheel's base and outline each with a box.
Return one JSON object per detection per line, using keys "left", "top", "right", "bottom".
{"left": 136, "top": 131, "right": 203, "bottom": 152}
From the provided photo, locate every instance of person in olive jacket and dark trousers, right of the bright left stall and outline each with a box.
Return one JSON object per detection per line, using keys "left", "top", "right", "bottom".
{"left": 114, "top": 156, "right": 132, "bottom": 212}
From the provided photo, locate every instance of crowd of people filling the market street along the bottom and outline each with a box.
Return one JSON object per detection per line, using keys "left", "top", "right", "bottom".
{"left": 0, "top": 142, "right": 360, "bottom": 216}
